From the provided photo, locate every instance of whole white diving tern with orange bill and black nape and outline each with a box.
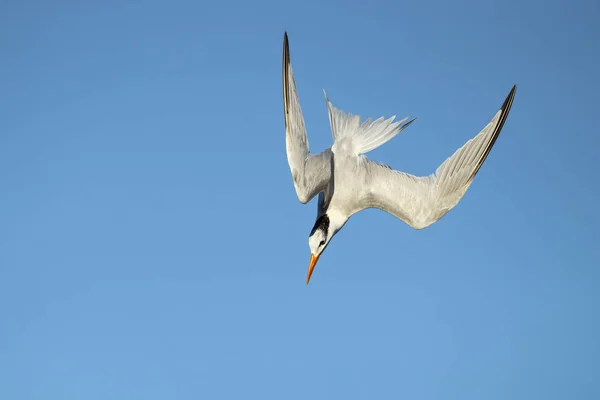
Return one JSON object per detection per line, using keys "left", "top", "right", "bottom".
{"left": 283, "top": 32, "right": 516, "bottom": 284}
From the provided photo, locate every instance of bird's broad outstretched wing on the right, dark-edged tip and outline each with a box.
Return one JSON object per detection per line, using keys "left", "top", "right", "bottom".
{"left": 361, "top": 86, "right": 516, "bottom": 229}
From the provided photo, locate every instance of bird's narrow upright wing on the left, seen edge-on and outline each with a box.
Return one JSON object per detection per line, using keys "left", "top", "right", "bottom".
{"left": 283, "top": 33, "right": 333, "bottom": 204}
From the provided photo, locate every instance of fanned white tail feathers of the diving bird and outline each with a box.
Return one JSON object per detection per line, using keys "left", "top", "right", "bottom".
{"left": 323, "top": 91, "right": 416, "bottom": 155}
